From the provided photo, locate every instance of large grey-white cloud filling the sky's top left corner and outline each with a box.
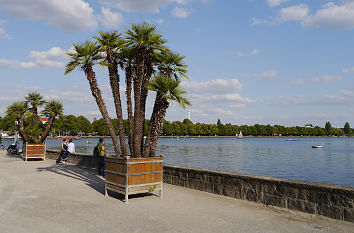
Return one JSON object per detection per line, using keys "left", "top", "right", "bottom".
{"left": 0, "top": 0, "right": 97, "bottom": 32}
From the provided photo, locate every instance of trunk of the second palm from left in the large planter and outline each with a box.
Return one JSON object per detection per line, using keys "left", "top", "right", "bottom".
{"left": 106, "top": 48, "right": 128, "bottom": 156}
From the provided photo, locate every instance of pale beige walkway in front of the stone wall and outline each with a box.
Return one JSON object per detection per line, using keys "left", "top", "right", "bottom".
{"left": 0, "top": 151, "right": 354, "bottom": 233}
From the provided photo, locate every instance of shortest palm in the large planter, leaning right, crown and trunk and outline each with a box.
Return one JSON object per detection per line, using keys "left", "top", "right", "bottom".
{"left": 143, "top": 75, "right": 191, "bottom": 157}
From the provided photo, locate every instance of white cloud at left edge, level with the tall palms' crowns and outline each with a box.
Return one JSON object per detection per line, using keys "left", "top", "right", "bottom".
{"left": 0, "top": 47, "right": 69, "bottom": 69}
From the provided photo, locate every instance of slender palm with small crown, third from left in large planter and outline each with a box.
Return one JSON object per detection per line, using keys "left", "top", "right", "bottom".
{"left": 118, "top": 47, "right": 136, "bottom": 153}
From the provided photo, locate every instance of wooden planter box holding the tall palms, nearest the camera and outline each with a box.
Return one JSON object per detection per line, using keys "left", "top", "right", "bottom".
{"left": 105, "top": 156, "right": 163, "bottom": 203}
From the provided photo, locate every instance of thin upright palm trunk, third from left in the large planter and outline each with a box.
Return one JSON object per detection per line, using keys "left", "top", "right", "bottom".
{"left": 125, "top": 65, "right": 134, "bottom": 154}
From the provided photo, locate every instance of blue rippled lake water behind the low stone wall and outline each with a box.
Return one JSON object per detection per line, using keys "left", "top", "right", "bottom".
{"left": 4, "top": 137, "right": 354, "bottom": 187}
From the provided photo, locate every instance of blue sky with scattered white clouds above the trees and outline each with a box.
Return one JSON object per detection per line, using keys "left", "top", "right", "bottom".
{"left": 0, "top": 0, "right": 354, "bottom": 127}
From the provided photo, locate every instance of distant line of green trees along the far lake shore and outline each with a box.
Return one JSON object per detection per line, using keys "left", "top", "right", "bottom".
{"left": 0, "top": 115, "right": 354, "bottom": 136}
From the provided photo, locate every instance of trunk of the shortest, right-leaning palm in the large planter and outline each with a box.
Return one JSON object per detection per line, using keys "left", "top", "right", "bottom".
{"left": 149, "top": 99, "right": 169, "bottom": 157}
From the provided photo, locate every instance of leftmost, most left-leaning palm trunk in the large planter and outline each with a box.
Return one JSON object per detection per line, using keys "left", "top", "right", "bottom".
{"left": 84, "top": 66, "right": 120, "bottom": 156}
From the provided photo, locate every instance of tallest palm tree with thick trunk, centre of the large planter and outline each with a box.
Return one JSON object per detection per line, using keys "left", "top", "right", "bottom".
{"left": 126, "top": 23, "right": 167, "bottom": 157}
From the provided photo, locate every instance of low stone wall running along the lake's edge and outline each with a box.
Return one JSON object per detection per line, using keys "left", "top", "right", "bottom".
{"left": 47, "top": 150, "right": 354, "bottom": 222}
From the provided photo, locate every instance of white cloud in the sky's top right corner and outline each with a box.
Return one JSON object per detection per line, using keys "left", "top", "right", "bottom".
{"left": 302, "top": 1, "right": 354, "bottom": 29}
